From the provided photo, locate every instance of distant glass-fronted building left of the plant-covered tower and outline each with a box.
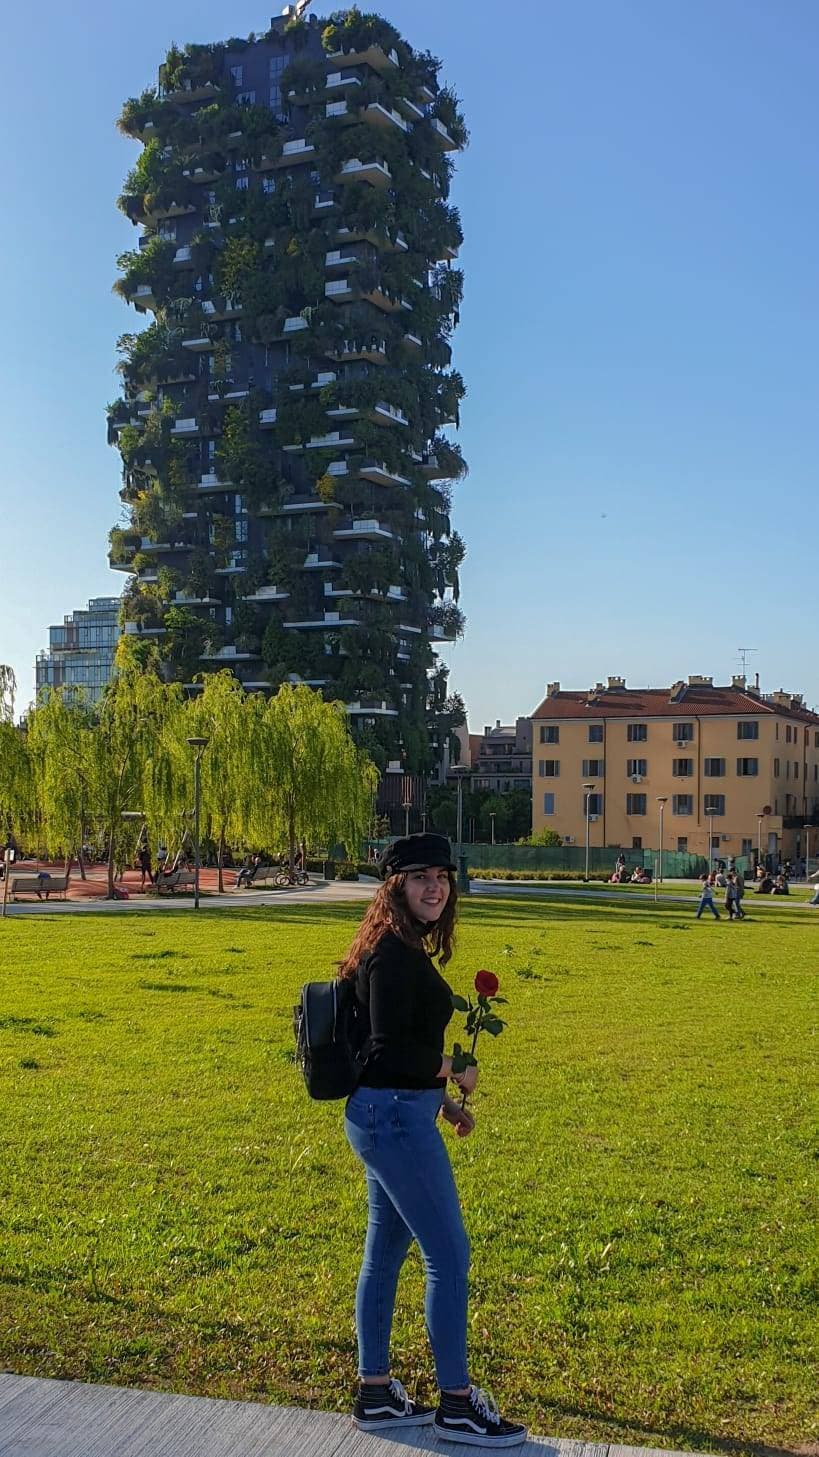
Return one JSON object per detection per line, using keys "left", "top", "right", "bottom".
{"left": 35, "top": 597, "right": 121, "bottom": 704}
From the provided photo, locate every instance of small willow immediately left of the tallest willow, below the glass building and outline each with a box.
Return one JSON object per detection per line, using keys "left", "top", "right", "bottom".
{"left": 26, "top": 689, "right": 96, "bottom": 879}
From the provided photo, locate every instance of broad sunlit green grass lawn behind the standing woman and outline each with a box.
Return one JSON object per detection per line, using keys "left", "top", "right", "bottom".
{"left": 0, "top": 898, "right": 819, "bottom": 1451}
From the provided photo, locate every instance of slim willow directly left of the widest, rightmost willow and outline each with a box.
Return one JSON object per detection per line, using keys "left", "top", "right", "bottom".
{"left": 185, "top": 670, "right": 258, "bottom": 892}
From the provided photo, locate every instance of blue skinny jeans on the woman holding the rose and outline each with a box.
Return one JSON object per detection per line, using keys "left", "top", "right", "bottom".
{"left": 344, "top": 1087, "right": 469, "bottom": 1390}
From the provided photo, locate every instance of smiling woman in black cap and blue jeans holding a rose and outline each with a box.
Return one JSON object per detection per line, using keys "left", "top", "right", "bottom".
{"left": 340, "top": 835, "right": 526, "bottom": 1447}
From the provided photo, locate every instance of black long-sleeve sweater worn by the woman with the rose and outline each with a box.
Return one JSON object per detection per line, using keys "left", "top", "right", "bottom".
{"left": 356, "top": 932, "right": 452, "bottom": 1088}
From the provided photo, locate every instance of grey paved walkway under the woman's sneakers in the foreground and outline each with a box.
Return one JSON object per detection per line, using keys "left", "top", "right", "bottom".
{"left": 0, "top": 1372, "right": 690, "bottom": 1457}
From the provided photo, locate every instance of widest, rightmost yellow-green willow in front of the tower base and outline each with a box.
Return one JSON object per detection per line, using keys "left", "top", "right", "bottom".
{"left": 249, "top": 683, "right": 377, "bottom": 867}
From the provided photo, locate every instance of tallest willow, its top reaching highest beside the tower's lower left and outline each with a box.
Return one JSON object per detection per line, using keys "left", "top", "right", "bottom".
{"left": 93, "top": 637, "right": 182, "bottom": 898}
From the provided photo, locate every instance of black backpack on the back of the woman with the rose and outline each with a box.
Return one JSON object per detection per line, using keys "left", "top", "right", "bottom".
{"left": 293, "top": 979, "right": 367, "bottom": 1101}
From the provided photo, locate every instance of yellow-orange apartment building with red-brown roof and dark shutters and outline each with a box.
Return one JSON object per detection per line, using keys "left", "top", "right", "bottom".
{"left": 532, "top": 676, "right": 819, "bottom": 860}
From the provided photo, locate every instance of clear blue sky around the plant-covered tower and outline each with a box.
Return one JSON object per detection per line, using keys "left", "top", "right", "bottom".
{"left": 0, "top": 0, "right": 819, "bottom": 727}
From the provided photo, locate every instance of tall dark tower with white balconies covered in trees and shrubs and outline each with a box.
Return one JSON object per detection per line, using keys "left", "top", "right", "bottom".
{"left": 108, "top": 9, "right": 466, "bottom": 772}
